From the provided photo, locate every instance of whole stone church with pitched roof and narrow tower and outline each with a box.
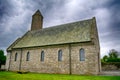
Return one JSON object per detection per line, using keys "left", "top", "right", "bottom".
{"left": 6, "top": 10, "right": 101, "bottom": 75}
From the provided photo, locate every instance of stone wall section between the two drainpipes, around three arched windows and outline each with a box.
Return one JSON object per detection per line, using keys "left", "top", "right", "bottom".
{"left": 21, "top": 45, "right": 69, "bottom": 74}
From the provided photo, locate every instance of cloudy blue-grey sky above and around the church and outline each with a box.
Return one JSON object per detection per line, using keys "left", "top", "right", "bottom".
{"left": 0, "top": 0, "right": 120, "bottom": 57}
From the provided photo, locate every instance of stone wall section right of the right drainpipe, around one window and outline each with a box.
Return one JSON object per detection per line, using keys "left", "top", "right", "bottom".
{"left": 71, "top": 44, "right": 99, "bottom": 75}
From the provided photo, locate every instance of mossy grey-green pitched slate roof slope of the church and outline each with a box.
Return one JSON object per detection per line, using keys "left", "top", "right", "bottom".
{"left": 7, "top": 19, "right": 93, "bottom": 48}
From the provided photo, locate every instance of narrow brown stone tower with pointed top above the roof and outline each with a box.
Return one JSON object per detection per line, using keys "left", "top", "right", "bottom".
{"left": 31, "top": 10, "right": 43, "bottom": 31}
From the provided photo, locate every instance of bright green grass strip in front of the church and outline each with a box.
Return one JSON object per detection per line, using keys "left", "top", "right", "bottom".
{"left": 0, "top": 72, "right": 120, "bottom": 80}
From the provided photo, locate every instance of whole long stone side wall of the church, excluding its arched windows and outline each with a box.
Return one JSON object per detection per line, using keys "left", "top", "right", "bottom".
{"left": 5, "top": 43, "right": 99, "bottom": 74}
